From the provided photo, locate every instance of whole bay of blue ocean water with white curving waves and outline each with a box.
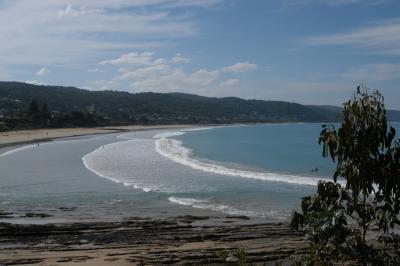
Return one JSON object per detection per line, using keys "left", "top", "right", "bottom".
{"left": 0, "top": 123, "right": 397, "bottom": 221}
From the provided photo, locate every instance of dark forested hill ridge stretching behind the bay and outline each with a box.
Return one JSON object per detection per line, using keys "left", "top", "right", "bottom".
{"left": 0, "top": 82, "right": 398, "bottom": 130}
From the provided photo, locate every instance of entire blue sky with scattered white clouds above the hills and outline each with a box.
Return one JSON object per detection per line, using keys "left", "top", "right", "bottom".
{"left": 0, "top": 0, "right": 400, "bottom": 110}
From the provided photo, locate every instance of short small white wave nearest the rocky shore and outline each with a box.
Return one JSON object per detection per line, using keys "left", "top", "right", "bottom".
{"left": 168, "top": 197, "right": 277, "bottom": 217}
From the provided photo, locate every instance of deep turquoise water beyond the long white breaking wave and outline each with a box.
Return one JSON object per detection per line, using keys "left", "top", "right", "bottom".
{"left": 176, "top": 124, "right": 335, "bottom": 177}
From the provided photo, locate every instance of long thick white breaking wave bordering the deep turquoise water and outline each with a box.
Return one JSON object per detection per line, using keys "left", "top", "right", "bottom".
{"left": 155, "top": 138, "right": 336, "bottom": 186}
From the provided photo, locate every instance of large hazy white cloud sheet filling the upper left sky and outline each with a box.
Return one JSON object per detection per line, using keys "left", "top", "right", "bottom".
{"left": 0, "top": 0, "right": 221, "bottom": 67}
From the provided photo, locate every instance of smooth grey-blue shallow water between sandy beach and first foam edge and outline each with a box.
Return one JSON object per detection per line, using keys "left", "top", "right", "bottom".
{"left": 0, "top": 131, "right": 217, "bottom": 223}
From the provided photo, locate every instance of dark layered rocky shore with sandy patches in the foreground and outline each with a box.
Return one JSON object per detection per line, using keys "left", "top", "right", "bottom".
{"left": 0, "top": 216, "right": 307, "bottom": 266}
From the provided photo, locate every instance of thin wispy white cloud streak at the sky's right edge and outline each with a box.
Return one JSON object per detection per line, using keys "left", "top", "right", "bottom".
{"left": 300, "top": 18, "right": 400, "bottom": 55}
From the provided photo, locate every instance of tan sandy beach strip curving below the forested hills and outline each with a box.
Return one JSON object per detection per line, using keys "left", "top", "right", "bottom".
{"left": 0, "top": 125, "right": 193, "bottom": 148}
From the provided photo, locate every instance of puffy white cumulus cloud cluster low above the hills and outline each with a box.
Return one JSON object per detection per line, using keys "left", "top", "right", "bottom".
{"left": 89, "top": 52, "right": 220, "bottom": 95}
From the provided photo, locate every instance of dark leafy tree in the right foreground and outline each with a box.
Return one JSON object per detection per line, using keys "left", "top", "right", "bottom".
{"left": 292, "top": 87, "right": 400, "bottom": 265}
